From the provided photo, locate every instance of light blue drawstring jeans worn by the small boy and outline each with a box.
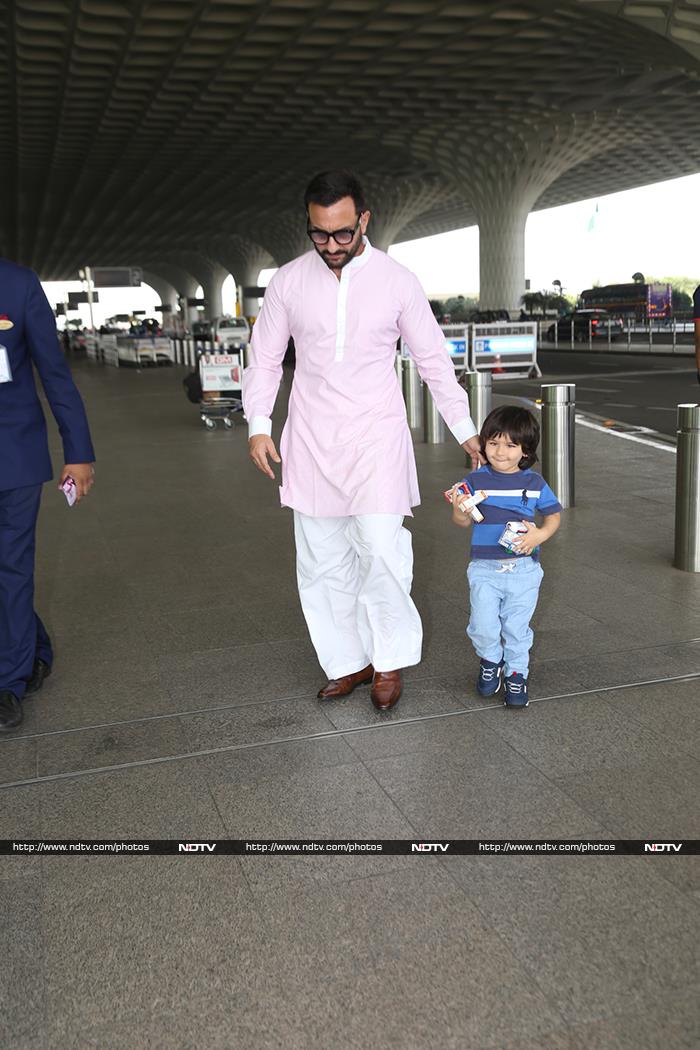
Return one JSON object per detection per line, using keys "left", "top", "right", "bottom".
{"left": 467, "top": 558, "right": 544, "bottom": 677}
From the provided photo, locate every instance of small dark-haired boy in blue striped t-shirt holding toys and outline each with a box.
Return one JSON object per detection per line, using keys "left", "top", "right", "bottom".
{"left": 452, "top": 405, "right": 561, "bottom": 708}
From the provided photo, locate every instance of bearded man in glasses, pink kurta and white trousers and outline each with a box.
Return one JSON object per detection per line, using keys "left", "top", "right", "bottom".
{"left": 243, "top": 172, "right": 479, "bottom": 710}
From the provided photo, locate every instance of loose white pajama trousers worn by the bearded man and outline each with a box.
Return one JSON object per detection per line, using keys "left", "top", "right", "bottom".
{"left": 294, "top": 510, "right": 423, "bottom": 678}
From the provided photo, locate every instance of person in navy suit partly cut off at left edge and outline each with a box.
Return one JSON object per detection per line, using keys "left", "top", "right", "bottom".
{"left": 0, "top": 259, "right": 94, "bottom": 732}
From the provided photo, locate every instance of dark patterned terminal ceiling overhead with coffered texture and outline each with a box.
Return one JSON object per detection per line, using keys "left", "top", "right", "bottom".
{"left": 0, "top": 0, "right": 700, "bottom": 279}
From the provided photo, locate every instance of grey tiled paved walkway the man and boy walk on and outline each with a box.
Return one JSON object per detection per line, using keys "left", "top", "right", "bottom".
{"left": 0, "top": 364, "right": 700, "bottom": 1050}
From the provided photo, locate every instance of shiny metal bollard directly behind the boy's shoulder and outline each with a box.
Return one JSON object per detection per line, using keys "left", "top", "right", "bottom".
{"left": 542, "top": 383, "right": 576, "bottom": 507}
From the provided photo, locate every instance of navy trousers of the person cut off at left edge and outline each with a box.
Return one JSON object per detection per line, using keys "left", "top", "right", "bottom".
{"left": 0, "top": 485, "right": 54, "bottom": 699}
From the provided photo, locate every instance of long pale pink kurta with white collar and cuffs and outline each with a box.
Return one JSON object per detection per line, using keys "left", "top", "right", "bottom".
{"left": 243, "top": 242, "right": 476, "bottom": 517}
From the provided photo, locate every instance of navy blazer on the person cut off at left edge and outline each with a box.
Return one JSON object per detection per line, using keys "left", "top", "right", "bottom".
{"left": 0, "top": 258, "right": 94, "bottom": 490}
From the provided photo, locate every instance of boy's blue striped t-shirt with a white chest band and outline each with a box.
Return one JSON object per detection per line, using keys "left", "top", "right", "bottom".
{"left": 464, "top": 465, "right": 561, "bottom": 561}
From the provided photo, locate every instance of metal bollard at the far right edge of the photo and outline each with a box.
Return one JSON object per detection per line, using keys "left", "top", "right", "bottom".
{"left": 674, "top": 404, "right": 700, "bottom": 572}
